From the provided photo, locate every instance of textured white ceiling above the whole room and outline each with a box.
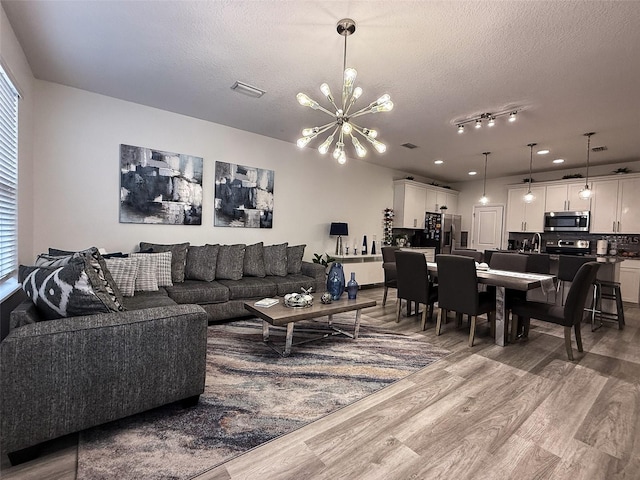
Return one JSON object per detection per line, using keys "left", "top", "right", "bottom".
{"left": 2, "top": 0, "right": 640, "bottom": 182}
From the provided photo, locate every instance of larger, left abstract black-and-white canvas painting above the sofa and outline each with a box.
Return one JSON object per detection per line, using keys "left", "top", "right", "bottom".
{"left": 120, "top": 145, "right": 202, "bottom": 225}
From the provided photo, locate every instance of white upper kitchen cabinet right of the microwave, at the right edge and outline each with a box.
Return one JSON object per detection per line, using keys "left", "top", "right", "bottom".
{"left": 590, "top": 177, "right": 640, "bottom": 234}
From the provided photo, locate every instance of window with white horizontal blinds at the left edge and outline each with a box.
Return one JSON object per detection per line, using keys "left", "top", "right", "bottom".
{"left": 0, "top": 67, "right": 18, "bottom": 282}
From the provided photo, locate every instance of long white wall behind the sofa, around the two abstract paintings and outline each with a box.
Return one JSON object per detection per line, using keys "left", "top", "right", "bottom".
{"left": 32, "top": 80, "right": 404, "bottom": 259}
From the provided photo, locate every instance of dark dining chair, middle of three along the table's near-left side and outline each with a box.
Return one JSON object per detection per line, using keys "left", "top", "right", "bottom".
{"left": 395, "top": 250, "right": 438, "bottom": 330}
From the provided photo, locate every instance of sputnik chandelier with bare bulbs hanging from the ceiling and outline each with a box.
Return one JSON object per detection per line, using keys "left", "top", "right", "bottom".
{"left": 296, "top": 18, "right": 393, "bottom": 164}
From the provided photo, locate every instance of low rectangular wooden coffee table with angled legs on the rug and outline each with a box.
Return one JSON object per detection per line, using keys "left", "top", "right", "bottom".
{"left": 244, "top": 295, "right": 376, "bottom": 357}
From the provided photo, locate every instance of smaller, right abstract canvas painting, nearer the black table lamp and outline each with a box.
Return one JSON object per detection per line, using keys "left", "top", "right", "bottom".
{"left": 213, "top": 162, "right": 274, "bottom": 228}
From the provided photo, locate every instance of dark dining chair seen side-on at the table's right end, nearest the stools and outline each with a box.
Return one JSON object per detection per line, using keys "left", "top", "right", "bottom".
{"left": 511, "top": 262, "right": 600, "bottom": 360}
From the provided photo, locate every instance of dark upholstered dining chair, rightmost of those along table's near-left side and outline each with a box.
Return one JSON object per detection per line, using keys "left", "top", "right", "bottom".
{"left": 436, "top": 255, "right": 496, "bottom": 347}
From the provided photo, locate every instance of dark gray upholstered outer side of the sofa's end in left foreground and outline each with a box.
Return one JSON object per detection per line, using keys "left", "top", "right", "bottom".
{"left": 0, "top": 305, "right": 207, "bottom": 452}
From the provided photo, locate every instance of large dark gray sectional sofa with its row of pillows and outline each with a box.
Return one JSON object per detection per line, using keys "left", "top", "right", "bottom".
{"left": 0, "top": 242, "right": 325, "bottom": 461}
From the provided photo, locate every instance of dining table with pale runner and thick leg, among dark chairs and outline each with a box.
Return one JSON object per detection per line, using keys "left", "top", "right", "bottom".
{"left": 427, "top": 262, "right": 557, "bottom": 347}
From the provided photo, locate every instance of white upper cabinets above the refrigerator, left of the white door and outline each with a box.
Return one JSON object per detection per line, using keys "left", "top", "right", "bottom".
{"left": 393, "top": 180, "right": 458, "bottom": 229}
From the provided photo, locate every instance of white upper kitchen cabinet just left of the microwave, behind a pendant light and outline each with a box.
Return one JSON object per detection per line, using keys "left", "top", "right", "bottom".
{"left": 507, "top": 186, "right": 546, "bottom": 232}
